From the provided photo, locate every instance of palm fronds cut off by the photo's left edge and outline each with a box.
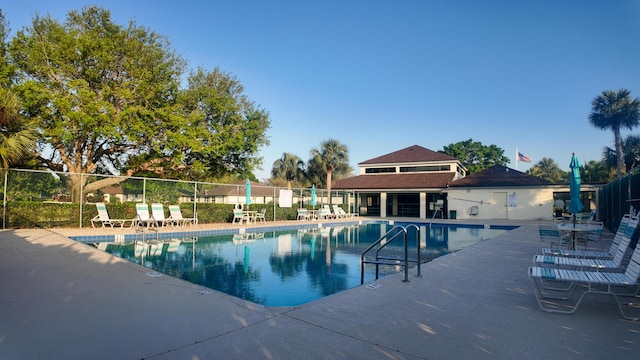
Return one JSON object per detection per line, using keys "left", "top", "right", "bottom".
{"left": 0, "top": 88, "right": 37, "bottom": 169}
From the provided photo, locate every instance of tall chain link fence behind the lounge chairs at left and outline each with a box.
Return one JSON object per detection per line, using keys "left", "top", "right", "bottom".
{"left": 2, "top": 169, "right": 357, "bottom": 229}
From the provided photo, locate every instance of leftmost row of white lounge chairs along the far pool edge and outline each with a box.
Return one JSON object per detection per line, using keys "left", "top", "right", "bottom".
{"left": 91, "top": 203, "right": 198, "bottom": 229}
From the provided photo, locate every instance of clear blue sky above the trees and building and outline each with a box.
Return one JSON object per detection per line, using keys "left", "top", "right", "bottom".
{"left": 5, "top": 0, "right": 640, "bottom": 180}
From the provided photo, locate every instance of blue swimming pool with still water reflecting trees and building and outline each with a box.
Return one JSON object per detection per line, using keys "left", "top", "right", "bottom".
{"left": 89, "top": 222, "right": 509, "bottom": 306}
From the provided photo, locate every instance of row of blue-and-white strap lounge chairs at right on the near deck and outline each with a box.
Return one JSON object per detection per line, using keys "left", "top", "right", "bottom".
{"left": 528, "top": 215, "right": 640, "bottom": 320}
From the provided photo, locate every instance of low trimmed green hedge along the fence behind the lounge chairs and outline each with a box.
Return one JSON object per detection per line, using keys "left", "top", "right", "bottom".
{"left": 6, "top": 201, "right": 298, "bottom": 228}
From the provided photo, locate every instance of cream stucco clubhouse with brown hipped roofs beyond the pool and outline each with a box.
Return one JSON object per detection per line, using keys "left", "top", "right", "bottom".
{"left": 333, "top": 145, "right": 597, "bottom": 220}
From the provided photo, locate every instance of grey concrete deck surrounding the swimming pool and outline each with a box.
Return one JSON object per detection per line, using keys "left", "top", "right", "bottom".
{"left": 0, "top": 221, "right": 640, "bottom": 360}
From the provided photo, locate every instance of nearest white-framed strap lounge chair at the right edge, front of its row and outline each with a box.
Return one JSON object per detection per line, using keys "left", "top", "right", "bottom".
{"left": 529, "top": 246, "right": 640, "bottom": 321}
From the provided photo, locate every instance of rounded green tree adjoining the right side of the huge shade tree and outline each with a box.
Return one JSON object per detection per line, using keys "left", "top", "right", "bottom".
{"left": 180, "top": 68, "right": 270, "bottom": 179}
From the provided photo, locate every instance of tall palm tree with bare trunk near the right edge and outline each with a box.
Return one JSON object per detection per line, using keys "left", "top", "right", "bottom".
{"left": 589, "top": 89, "right": 640, "bottom": 176}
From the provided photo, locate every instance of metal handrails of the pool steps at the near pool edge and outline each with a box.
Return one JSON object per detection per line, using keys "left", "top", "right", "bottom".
{"left": 360, "top": 224, "right": 422, "bottom": 285}
